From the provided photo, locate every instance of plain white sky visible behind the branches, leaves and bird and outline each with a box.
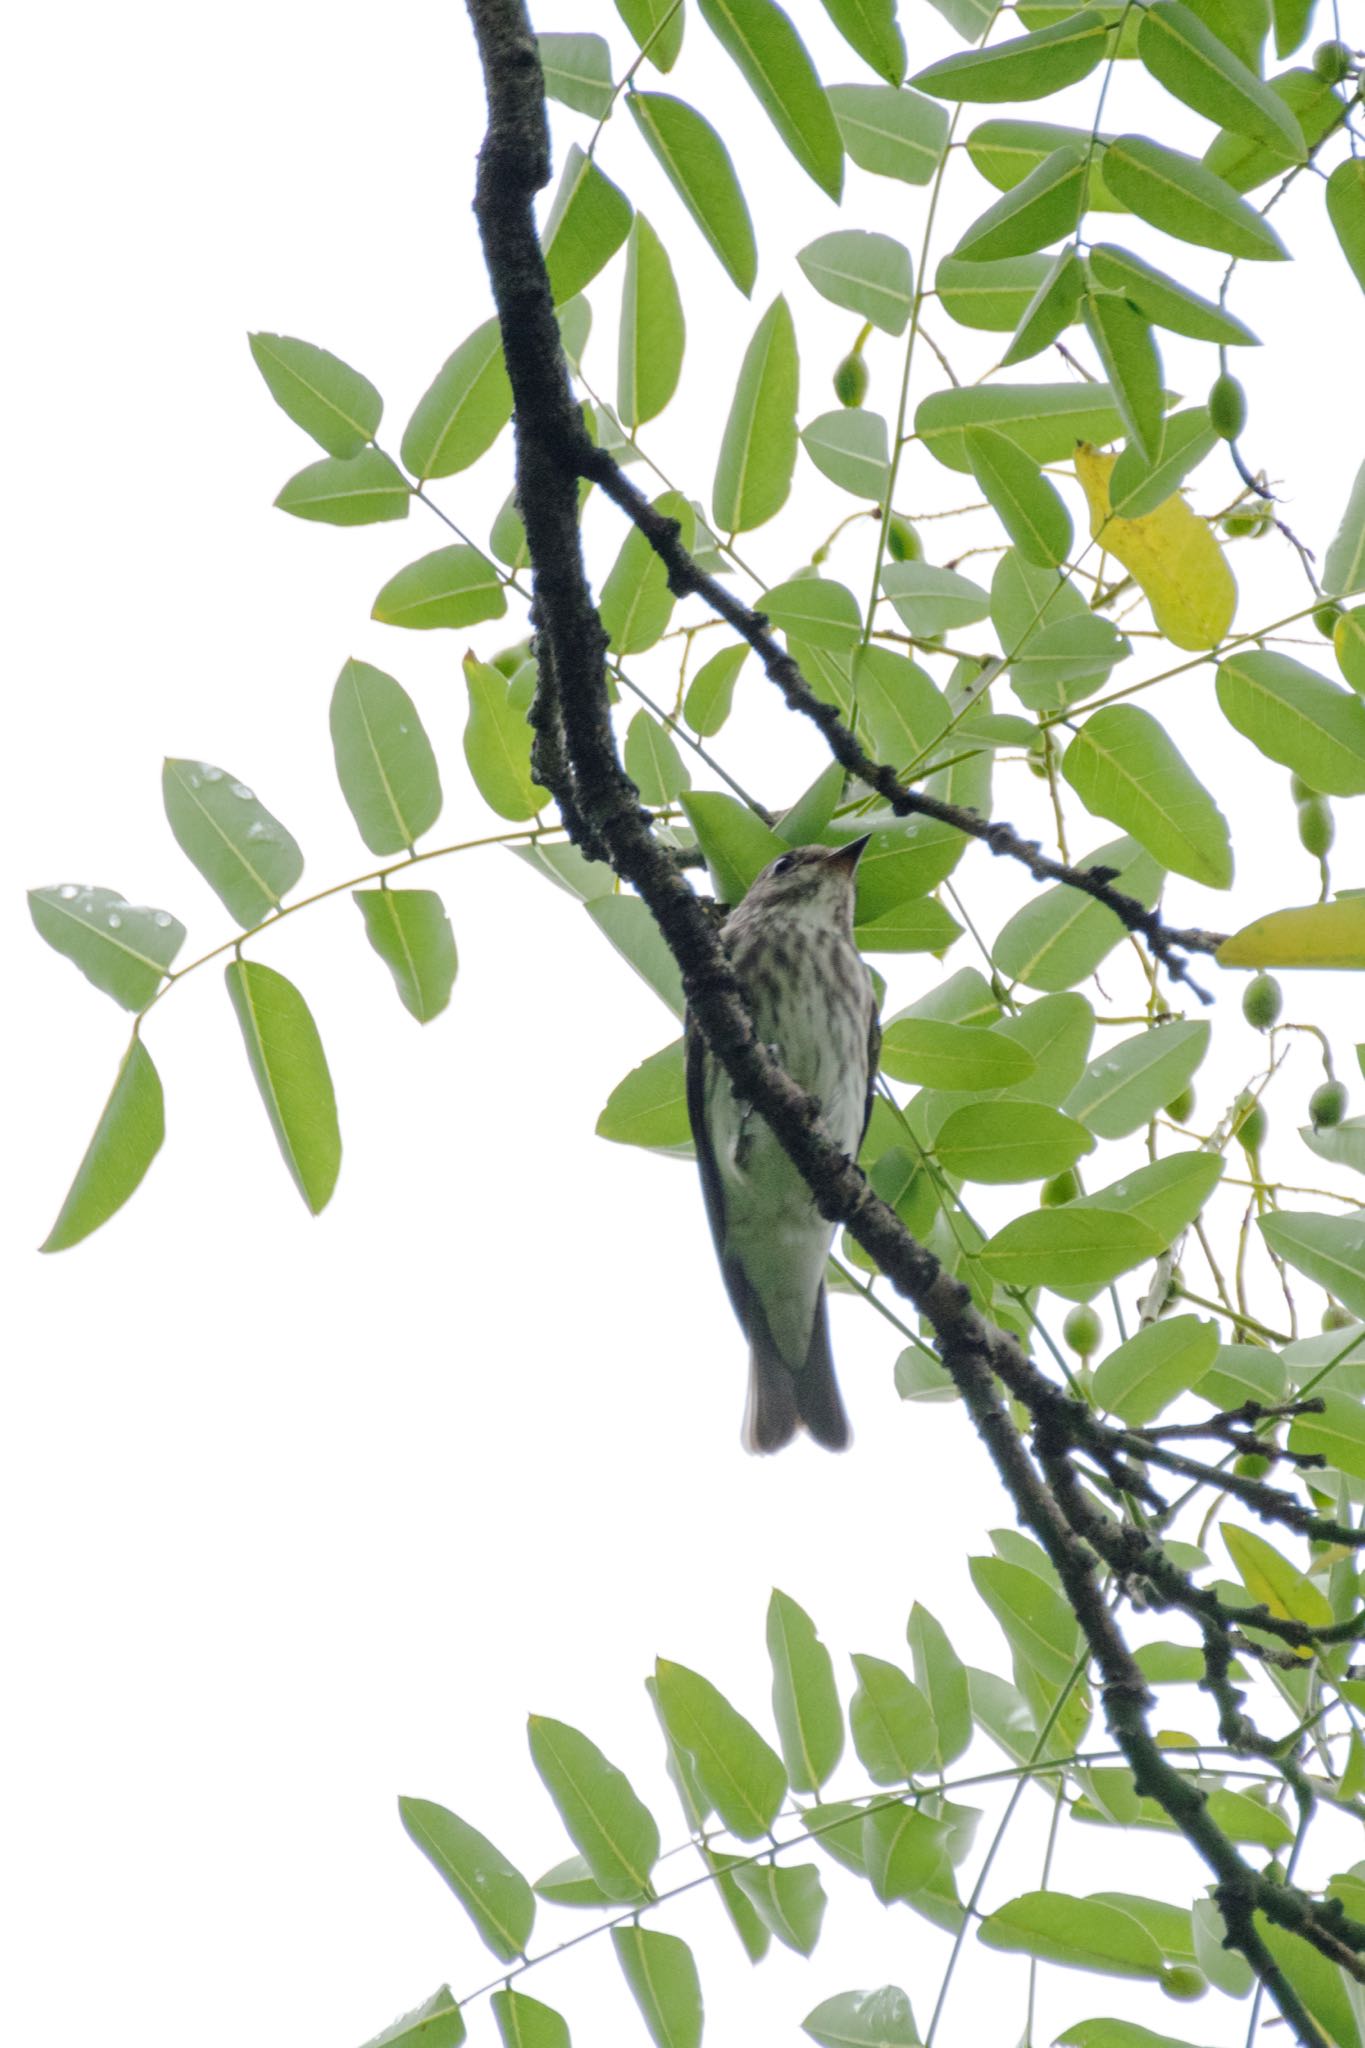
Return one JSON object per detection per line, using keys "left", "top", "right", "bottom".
{"left": 0, "top": 0, "right": 1365, "bottom": 2048}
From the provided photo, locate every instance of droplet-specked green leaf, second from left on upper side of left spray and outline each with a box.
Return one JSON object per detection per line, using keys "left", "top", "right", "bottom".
{"left": 162, "top": 760, "right": 303, "bottom": 930}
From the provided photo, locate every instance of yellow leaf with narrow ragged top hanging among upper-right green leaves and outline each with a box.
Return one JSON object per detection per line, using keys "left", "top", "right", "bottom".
{"left": 1074, "top": 440, "right": 1236, "bottom": 653}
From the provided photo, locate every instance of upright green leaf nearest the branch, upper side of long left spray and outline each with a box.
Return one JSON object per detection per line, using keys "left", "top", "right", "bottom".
{"left": 332, "top": 662, "right": 440, "bottom": 854}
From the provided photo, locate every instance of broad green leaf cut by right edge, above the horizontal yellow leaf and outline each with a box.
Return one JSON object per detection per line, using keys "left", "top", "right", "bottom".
{"left": 1218, "top": 647, "right": 1365, "bottom": 797}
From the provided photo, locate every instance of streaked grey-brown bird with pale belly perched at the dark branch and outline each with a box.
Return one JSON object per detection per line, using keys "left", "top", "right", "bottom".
{"left": 686, "top": 838, "right": 882, "bottom": 1452}
